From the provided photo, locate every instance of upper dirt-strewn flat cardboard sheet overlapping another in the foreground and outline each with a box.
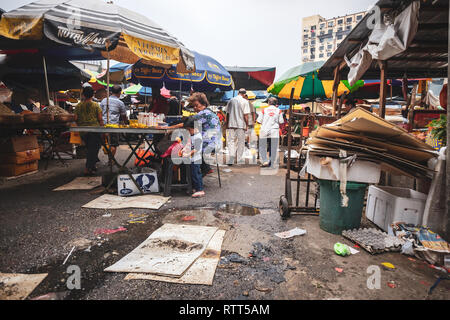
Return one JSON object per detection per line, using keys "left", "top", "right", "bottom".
{"left": 105, "top": 223, "right": 218, "bottom": 278}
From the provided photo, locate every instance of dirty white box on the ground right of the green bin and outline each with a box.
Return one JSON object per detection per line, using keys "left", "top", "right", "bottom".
{"left": 366, "top": 186, "right": 427, "bottom": 232}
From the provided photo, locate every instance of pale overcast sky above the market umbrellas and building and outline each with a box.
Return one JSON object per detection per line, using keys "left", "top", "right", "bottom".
{"left": 0, "top": 0, "right": 376, "bottom": 78}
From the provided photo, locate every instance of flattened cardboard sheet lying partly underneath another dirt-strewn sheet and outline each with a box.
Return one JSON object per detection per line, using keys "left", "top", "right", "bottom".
{"left": 125, "top": 230, "right": 225, "bottom": 286}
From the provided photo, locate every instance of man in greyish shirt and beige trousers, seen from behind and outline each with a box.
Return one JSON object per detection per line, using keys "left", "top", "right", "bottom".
{"left": 225, "top": 89, "right": 250, "bottom": 165}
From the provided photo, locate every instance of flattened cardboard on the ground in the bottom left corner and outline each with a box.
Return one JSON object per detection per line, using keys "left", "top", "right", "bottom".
{"left": 0, "top": 273, "right": 48, "bottom": 300}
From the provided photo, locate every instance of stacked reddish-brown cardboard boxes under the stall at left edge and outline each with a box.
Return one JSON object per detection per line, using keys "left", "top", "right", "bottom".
{"left": 0, "top": 136, "right": 40, "bottom": 177}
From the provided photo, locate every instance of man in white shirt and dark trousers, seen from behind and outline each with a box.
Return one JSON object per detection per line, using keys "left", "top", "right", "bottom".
{"left": 256, "top": 97, "right": 284, "bottom": 167}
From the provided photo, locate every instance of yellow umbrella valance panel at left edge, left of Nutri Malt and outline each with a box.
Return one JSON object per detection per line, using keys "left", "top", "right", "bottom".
{"left": 0, "top": 17, "right": 42, "bottom": 40}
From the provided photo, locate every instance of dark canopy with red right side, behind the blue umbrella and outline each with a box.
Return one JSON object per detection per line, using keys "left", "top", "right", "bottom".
{"left": 225, "top": 66, "right": 276, "bottom": 90}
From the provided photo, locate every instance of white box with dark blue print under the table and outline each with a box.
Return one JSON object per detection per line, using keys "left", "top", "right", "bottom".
{"left": 117, "top": 171, "right": 159, "bottom": 197}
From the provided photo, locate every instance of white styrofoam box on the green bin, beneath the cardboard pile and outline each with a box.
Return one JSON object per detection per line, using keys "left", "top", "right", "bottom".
{"left": 306, "top": 156, "right": 381, "bottom": 183}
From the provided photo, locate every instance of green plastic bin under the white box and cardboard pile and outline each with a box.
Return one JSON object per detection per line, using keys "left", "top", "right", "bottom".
{"left": 319, "top": 179, "right": 368, "bottom": 234}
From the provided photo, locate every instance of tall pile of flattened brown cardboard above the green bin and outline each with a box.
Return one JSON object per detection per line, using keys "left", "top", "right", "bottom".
{"left": 306, "top": 108, "right": 438, "bottom": 178}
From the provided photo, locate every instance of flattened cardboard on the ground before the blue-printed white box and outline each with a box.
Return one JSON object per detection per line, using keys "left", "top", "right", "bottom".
{"left": 83, "top": 194, "right": 170, "bottom": 210}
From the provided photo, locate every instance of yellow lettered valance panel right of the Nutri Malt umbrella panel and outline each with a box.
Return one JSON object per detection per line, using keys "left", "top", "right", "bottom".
{"left": 122, "top": 33, "right": 180, "bottom": 64}
